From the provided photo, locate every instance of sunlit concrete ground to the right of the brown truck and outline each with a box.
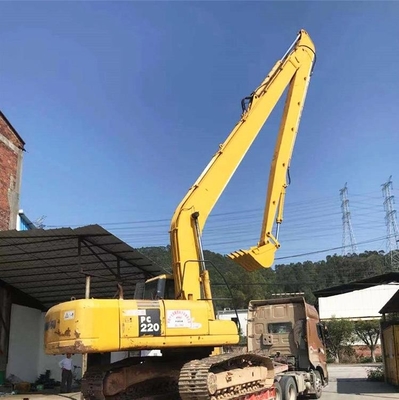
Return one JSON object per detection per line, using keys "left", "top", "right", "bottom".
{"left": 322, "top": 364, "right": 399, "bottom": 400}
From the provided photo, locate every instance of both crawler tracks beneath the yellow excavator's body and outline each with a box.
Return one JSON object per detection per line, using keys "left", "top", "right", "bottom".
{"left": 82, "top": 353, "right": 274, "bottom": 400}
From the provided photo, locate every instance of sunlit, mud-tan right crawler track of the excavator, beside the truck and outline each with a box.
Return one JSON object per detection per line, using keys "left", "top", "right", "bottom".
{"left": 179, "top": 353, "right": 274, "bottom": 400}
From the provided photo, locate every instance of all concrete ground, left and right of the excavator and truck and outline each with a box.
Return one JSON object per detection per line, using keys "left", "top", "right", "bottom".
{"left": 0, "top": 364, "right": 399, "bottom": 400}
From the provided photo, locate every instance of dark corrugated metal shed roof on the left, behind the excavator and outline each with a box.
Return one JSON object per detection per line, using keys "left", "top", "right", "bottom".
{"left": 0, "top": 225, "right": 164, "bottom": 309}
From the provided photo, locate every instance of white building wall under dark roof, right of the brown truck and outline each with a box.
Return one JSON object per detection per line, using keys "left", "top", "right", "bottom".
{"left": 319, "top": 284, "right": 399, "bottom": 319}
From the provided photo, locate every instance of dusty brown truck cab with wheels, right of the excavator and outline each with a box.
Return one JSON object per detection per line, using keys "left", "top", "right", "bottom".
{"left": 247, "top": 297, "right": 328, "bottom": 399}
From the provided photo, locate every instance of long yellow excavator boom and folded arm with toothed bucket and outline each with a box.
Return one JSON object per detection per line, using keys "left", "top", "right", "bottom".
{"left": 170, "top": 30, "right": 315, "bottom": 300}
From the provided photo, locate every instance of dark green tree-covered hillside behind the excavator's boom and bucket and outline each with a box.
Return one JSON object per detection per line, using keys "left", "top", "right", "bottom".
{"left": 138, "top": 245, "right": 385, "bottom": 309}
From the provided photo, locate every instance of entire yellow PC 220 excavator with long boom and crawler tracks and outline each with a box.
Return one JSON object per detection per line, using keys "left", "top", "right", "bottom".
{"left": 45, "top": 30, "right": 315, "bottom": 400}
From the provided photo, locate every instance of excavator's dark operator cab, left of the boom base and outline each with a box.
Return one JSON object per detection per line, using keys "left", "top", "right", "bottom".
{"left": 134, "top": 274, "right": 175, "bottom": 300}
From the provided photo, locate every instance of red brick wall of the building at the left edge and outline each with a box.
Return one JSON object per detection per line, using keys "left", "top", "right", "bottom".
{"left": 0, "top": 115, "right": 23, "bottom": 231}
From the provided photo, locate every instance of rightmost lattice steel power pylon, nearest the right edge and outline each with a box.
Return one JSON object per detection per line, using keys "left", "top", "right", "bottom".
{"left": 381, "top": 175, "right": 399, "bottom": 271}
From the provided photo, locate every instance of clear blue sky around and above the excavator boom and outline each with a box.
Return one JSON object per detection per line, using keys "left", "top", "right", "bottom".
{"left": 0, "top": 1, "right": 399, "bottom": 262}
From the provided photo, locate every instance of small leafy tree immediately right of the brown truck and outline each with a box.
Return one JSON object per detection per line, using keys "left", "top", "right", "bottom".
{"left": 325, "top": 318, "right": 354, "bottom": 363}
